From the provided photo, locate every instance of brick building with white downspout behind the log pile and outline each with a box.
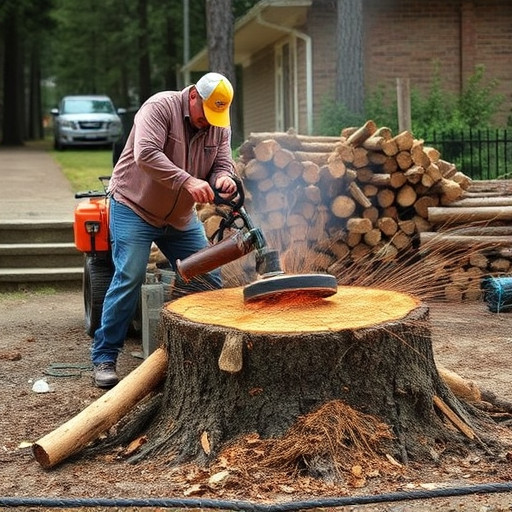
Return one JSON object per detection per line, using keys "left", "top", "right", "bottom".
{"left": 184, "top": 0, "right": 512, "bottom": 135}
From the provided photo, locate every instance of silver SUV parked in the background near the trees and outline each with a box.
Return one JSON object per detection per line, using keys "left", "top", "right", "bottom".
{"left": 51, "top": 95, "right": 125, "bottom": 150}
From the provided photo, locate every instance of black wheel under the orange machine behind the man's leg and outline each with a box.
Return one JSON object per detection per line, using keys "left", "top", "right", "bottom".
{"left": 82, "top": 254, "right": 114, "bottom": 338}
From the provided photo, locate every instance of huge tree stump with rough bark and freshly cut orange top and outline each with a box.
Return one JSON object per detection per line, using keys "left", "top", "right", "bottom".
{"left": 136, "top": 286, "right": 496, "bottom": 472}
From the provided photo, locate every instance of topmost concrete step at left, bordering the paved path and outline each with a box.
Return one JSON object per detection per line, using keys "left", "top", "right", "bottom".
{"left": 0, "top": 219, "right": 74, "bottom": 244}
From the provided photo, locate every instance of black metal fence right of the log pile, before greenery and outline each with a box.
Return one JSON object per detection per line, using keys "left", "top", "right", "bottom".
{"left": 424, "top": 129, "right": 512, "bottom": 180}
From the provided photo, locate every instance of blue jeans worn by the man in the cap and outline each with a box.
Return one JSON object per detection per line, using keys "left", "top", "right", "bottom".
{"left": 91, "top": 199, "right": 222, "bottom": 364}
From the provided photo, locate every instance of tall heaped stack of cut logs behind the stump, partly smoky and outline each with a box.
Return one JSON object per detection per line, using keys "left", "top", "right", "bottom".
{"left": 198, "top": 120, "right": 512, "bottom": 300}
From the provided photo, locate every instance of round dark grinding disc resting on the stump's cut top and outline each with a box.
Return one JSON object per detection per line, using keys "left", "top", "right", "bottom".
{"left": 243, "top": 274, "right": 338, "bottom": 302}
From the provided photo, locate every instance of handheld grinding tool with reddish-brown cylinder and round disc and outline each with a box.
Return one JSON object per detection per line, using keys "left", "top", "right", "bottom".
{"left": 176, "top": 177, "right": 338, "bottom": 302}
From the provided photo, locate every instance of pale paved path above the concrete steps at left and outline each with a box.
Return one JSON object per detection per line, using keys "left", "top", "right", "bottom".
{"left": 0, "top": 147, "right": 77, "bottom": 222}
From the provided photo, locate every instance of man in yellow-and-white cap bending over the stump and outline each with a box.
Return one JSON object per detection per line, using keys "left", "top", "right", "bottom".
{"left": 91, "top": 73, "right": 236, "bottom": 388}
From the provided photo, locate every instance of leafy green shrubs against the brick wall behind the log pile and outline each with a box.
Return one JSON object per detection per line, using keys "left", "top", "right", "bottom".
{"left": 316, "top": 62, "right": 512, "bottom": 179}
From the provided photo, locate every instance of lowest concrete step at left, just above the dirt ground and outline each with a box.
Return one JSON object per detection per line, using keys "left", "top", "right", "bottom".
{"left": 0, "top": 266, "right": 84, "bottom": 291}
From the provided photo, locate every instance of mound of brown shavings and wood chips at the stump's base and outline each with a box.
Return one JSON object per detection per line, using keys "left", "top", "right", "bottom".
{"left": 210, "top": 400, "right": 401, "bottom": 487}
